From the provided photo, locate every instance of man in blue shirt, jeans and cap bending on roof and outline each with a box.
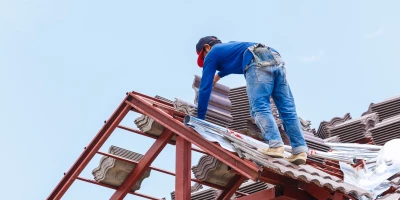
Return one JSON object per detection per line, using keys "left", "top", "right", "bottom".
{"left": 196, "top": 36, "right": 308, "bottom": 165}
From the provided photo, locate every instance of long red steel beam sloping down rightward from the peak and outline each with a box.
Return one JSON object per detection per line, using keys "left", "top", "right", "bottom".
{"left": 126, "top": 93, "right": 260, "bottom": 181}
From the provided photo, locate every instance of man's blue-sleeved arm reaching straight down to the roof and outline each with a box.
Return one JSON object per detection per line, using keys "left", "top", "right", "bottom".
{"left": 197, "top": 51, "right": 217, "bottom": 120}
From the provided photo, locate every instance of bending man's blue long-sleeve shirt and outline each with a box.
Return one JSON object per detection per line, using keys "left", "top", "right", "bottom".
{"left": 197, "top": 42, "right": 256, "bottom": 120}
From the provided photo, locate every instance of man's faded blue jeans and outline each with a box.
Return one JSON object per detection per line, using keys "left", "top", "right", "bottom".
{"left": 245, "top": 44, "right": 308, "bottom": 154}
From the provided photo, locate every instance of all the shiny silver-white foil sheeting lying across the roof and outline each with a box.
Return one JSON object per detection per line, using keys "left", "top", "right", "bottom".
{"left": 184, "top": 115, "right": 400, "bottom": 199}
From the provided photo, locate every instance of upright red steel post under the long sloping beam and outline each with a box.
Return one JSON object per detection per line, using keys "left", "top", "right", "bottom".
{"left": 175, "top": 136, "right": 192, "bottom": 200}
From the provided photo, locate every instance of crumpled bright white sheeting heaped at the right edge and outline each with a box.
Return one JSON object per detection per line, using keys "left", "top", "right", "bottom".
{"left": 340, "top": 139, "right": 400, "bottom": 198}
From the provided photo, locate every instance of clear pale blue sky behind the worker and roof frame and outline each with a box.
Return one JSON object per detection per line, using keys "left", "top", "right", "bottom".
{"left": 0, "top": 0, "right": 400, "bottom": 200}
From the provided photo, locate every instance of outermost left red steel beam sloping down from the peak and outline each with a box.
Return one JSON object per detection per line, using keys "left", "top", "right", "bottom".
{"left": 47, "top": 95, "right": 132, "bottom": 200}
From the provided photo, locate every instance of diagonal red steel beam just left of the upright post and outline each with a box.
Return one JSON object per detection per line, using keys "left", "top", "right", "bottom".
{"left": 110, "top": 128, "right": 175, "bottom": 200}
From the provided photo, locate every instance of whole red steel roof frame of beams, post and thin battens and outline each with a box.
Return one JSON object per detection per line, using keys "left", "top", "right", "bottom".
{"left": 47, "top": 92, "right": 356, "bottom": 200}
